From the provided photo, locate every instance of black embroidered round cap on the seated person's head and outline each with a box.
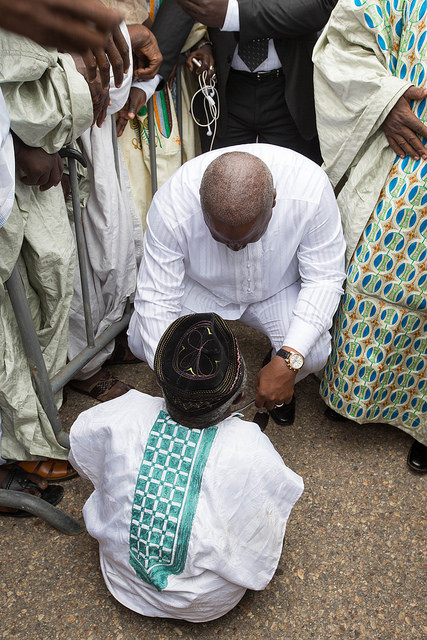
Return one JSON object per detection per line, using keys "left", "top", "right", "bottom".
{"left": 154, "top": 313, "right": 244, "bottom": 417}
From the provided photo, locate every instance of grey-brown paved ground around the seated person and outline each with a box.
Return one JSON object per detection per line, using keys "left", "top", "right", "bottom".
{"left": 0, "top": 324, "right": 427, "bottom": 640}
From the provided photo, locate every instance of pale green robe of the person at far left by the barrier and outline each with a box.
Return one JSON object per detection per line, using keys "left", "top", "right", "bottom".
{"left": 0, "top": 31, "right": 93, "bottom": 460}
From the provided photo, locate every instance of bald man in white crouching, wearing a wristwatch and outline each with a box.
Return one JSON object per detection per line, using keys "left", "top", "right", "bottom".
{"left": 128, "top": 144, "right": 345, "bottom": 426}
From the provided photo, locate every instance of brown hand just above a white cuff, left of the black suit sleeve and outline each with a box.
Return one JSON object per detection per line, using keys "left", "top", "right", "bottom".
{"left": 128, "top": 24, "right": 163, "bottom": 82}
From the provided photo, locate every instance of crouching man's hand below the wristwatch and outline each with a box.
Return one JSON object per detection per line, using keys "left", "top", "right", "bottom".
{"left": 255, "top": 356, "right": 296, "bottom": 411}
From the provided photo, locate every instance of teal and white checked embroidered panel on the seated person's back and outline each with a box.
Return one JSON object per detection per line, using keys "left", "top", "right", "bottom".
{"left": 129, "top": 411, "right": 217, "bottom": 591}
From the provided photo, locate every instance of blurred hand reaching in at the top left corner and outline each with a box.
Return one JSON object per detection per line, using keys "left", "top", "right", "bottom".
{"left": 0, "top": 0, "right": 121, "bottom": 53}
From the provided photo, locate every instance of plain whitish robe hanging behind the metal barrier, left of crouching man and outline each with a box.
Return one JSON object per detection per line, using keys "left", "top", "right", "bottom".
{"left": 68, "top": 23, "right": 142, "bottom": 379}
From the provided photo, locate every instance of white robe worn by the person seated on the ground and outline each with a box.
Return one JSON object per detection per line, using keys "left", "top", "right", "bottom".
{"left": 70, "top": 391, "right": 304, "bottom": 622}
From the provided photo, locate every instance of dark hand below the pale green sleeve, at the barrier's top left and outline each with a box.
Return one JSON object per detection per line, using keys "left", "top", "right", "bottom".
{"left": 13, "top": 134, "right": 64, "bottom": 191}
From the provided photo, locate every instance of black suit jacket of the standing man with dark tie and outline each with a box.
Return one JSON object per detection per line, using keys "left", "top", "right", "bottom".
{"left": 153, "top": 0, "right": 337, "bottom": 140}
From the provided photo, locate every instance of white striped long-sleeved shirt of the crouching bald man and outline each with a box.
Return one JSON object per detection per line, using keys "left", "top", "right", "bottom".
{"left": 129, "top": 144, "right": 345, "bottom": 367}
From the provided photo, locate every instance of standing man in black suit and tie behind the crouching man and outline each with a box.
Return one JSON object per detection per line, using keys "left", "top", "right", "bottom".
{"left": 153, "top": 0, "right": 336, "bottom": 163}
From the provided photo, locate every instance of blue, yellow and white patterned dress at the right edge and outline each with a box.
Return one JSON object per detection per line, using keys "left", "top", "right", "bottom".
{"left": 320, "top": 0, "right": 427, "bottom": 444}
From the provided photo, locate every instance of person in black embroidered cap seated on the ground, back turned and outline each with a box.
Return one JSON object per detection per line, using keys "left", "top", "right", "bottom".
{"left": 70, "top": 313, "right": 303, "bottom": 622}
